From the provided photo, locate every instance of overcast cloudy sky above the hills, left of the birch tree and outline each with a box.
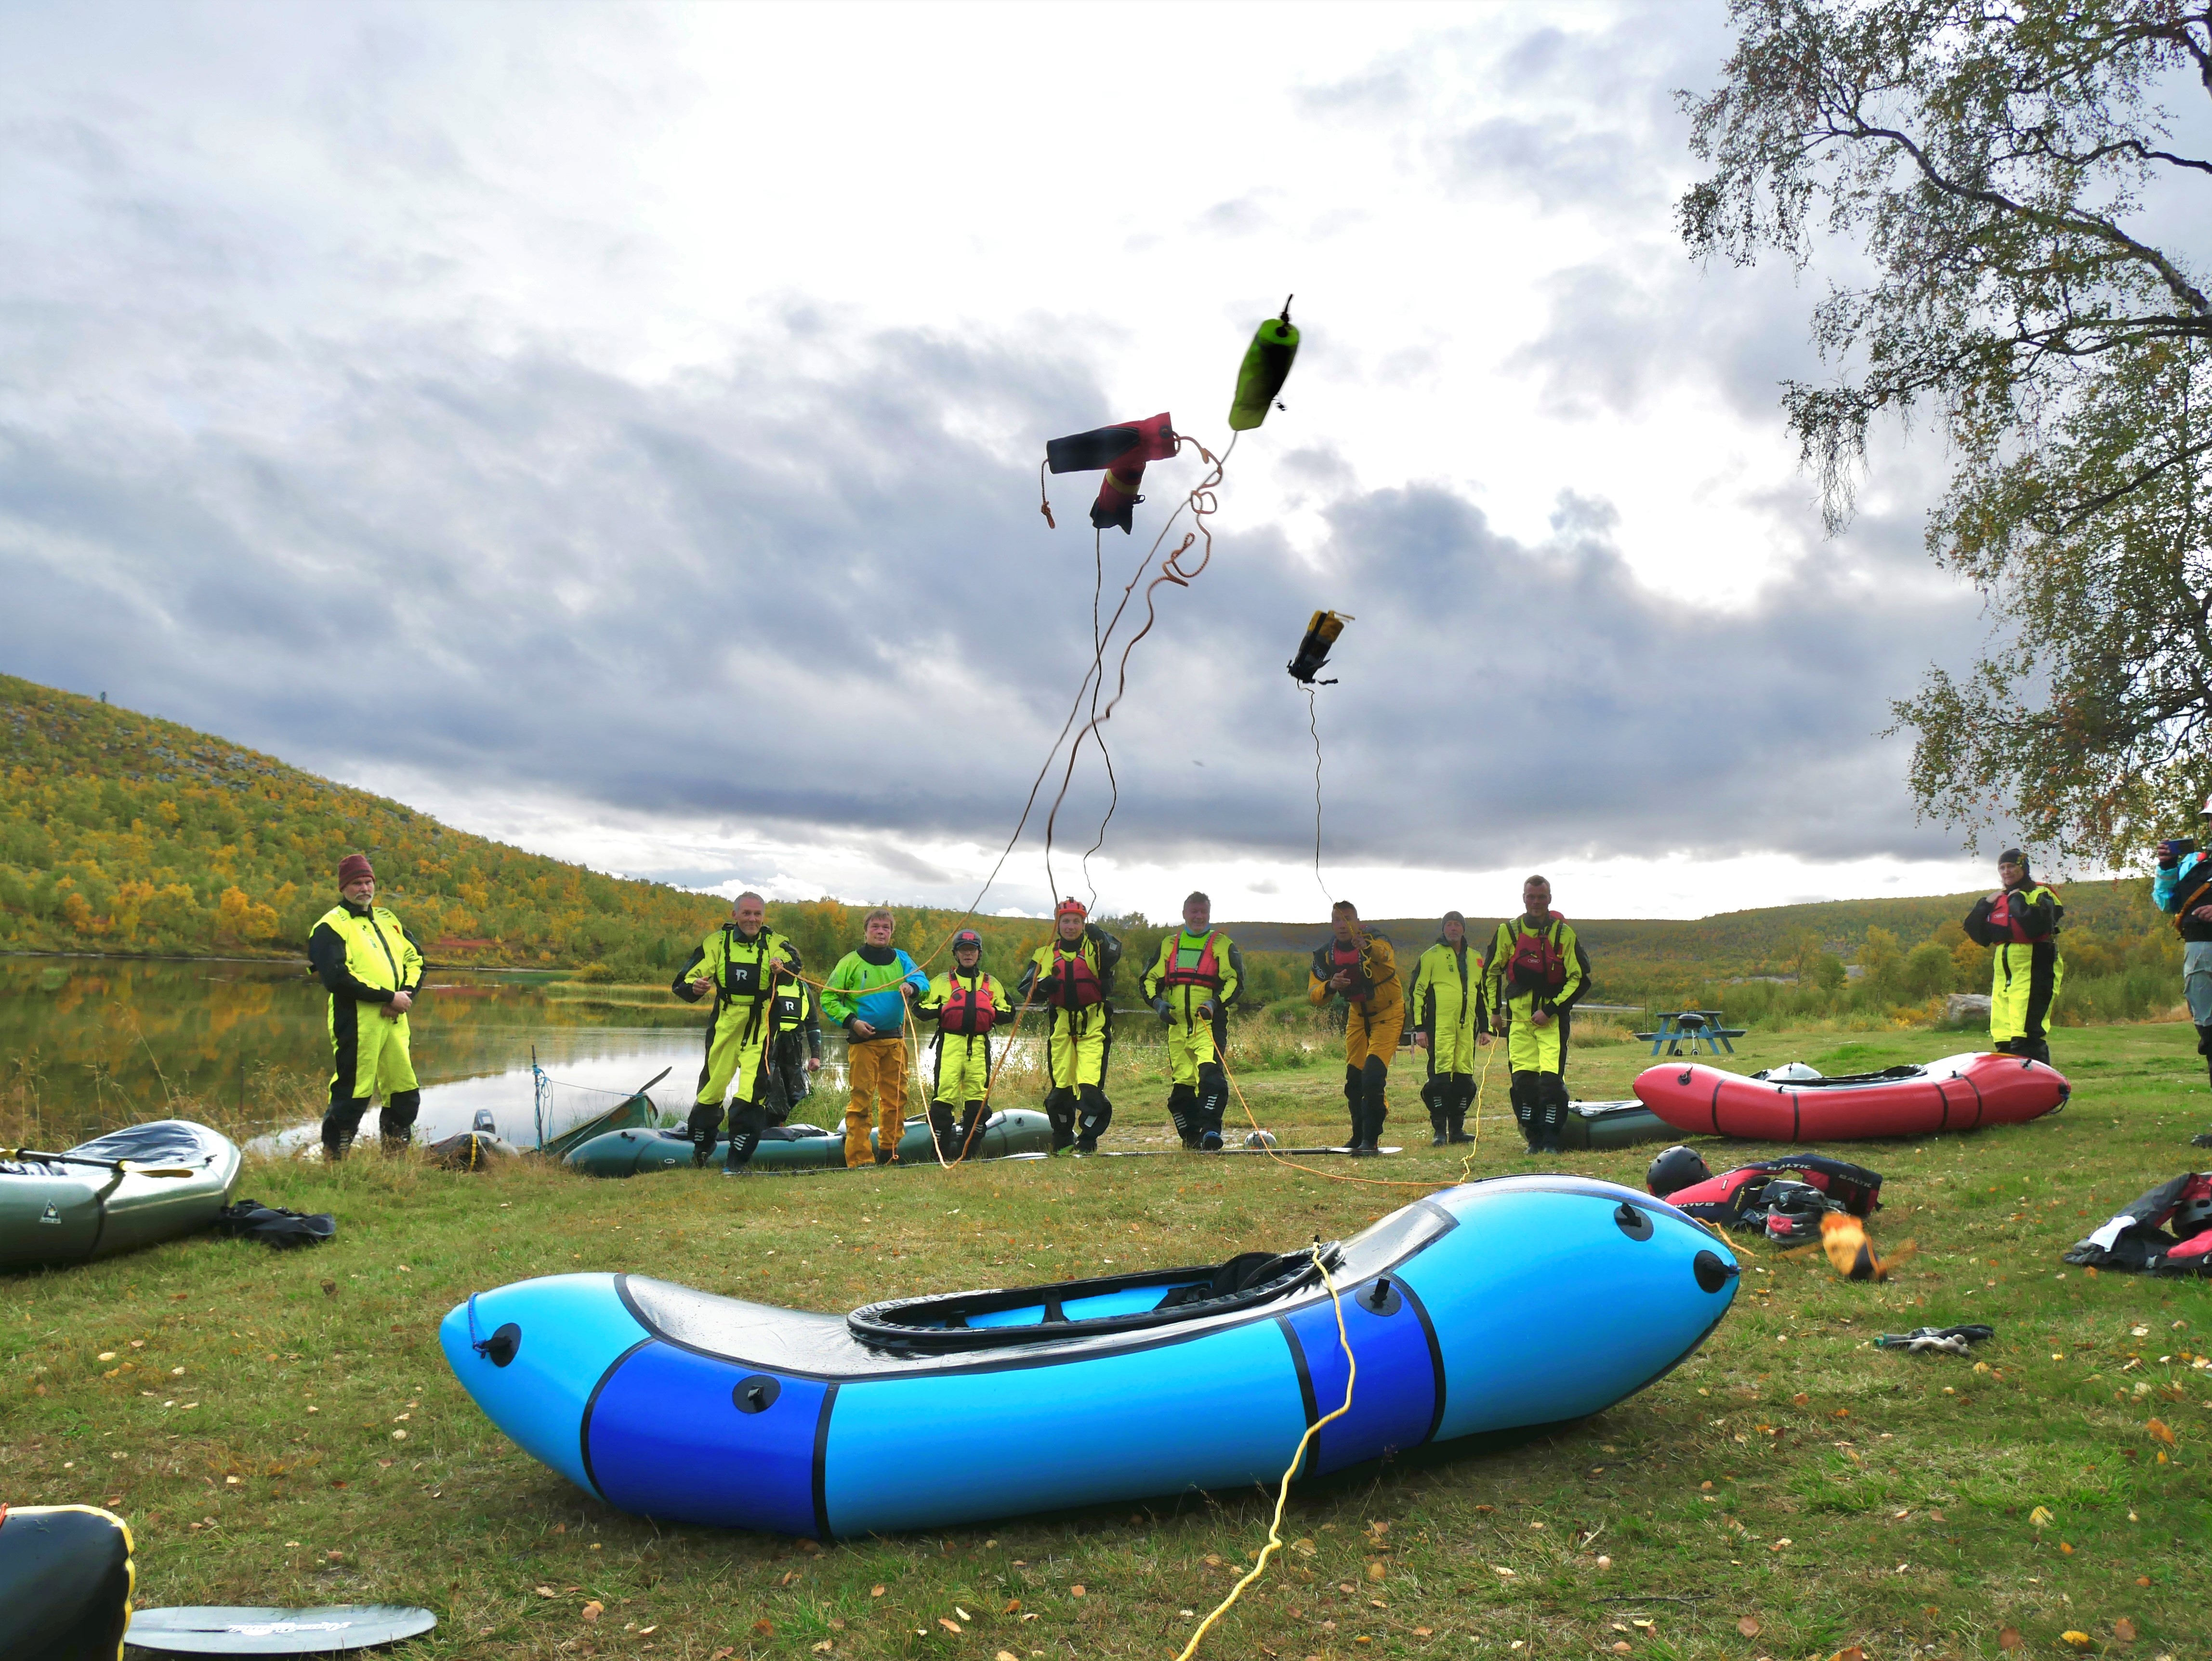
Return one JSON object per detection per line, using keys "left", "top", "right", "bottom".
{"left": 0, "top": 2, "right": 1987, "bottom": 918}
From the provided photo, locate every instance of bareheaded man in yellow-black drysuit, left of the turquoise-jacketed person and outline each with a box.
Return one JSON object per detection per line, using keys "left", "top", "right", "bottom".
{"left": 668, "top": 889, "right": 801, "bottom": 1174}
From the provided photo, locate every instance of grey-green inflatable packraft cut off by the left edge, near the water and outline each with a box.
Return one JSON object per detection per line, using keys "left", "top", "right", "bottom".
{"left": 0, "top": 1119, "right": 239, "bottom": 1267}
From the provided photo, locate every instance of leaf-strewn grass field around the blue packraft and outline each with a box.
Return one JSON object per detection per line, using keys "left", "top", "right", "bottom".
{"left": 0, "top": 1024, "right": 2212, "bottom": 1661}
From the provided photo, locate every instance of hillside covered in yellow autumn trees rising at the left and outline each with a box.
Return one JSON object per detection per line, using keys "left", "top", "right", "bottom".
{"left": 0, "top": 674, "right": 1049, "bottom": 976}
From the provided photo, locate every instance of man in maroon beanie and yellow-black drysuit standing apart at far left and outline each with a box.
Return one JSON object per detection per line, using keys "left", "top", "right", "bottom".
{"left": 307, "top": 854, "right": 422, "bottom": 1161}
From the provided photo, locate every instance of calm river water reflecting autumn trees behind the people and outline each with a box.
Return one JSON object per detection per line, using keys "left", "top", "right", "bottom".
{"left": 0, "top": 958, "right": 1066, "bottom": 1146}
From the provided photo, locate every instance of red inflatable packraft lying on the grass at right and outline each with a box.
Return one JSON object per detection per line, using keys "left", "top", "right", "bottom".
{"left": 1634, "top": 1053, "right": 2068, "bottom": 1141}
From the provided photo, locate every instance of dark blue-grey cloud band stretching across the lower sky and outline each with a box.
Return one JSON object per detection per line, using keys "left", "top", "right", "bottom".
{"left": 0, "top": 316, "right": 1971, "bottom": 880}
